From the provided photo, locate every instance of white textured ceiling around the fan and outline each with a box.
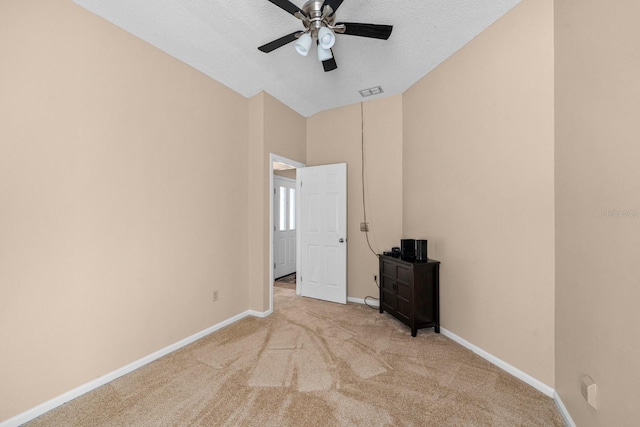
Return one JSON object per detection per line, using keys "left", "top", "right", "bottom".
{"left": 74, "top": 0, "right": 520, "bottom": 117}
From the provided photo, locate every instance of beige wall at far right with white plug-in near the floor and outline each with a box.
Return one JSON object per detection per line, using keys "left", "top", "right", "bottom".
{"left": 555, "top": 0, "right": 640, "bottom": 427}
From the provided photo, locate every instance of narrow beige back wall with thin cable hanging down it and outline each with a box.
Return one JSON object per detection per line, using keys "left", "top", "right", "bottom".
{"left": 307, "top": 96, "right": 402, "bottom": 299}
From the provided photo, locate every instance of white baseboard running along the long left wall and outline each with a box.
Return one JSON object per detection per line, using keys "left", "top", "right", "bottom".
{"left": 0, "top": 310, "right": 255, "bottom": 427}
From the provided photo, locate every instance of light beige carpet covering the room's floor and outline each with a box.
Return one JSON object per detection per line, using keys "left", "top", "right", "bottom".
{"left": 28, "top": 287, "right": 564, "bottom": 427}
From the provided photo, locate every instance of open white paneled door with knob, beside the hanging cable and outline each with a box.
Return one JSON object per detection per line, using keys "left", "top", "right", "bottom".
{"left": 297, "top": 163, "right": 347, "bottom": 304}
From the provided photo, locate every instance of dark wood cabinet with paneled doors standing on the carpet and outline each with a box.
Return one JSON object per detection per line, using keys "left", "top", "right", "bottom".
{"left": 379, "top": 255, "right": 440, "bottom": 337}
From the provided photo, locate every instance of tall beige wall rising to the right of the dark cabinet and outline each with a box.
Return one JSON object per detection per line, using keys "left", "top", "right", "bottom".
{"left": 403, "top": 0, "right": 555, "bottom": 387}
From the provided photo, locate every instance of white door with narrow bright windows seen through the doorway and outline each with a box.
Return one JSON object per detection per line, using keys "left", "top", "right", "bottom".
{"left": 273, "top": 176, "right": 296, "bottom": 279}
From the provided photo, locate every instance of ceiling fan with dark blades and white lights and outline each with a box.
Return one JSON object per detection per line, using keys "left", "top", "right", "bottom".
{"left": 258, "top": 0, "right": 393, "bottom": 72}
